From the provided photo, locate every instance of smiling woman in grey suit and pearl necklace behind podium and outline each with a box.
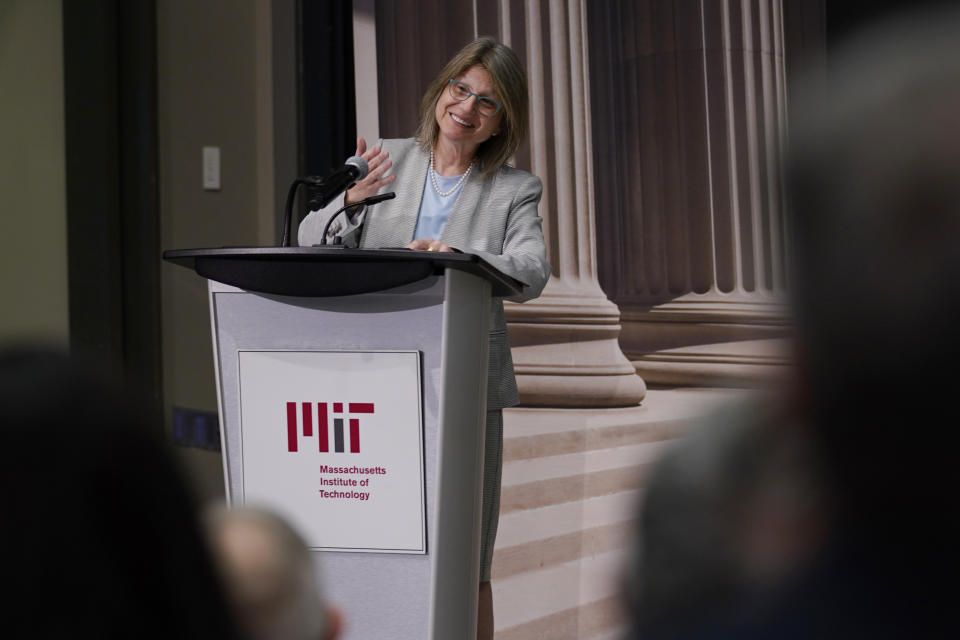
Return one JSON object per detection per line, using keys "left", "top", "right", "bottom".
{"left": 299, "top": 38, "right": 550, "bottom": 638}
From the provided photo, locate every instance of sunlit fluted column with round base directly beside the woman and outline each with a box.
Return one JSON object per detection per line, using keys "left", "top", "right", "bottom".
{"left": 499, "top": 0, "right": 646, "bottom": 407}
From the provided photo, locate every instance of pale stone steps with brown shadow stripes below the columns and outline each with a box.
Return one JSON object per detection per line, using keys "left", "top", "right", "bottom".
{"left": 493, "top": 388, "right": 738, "bottom": 640}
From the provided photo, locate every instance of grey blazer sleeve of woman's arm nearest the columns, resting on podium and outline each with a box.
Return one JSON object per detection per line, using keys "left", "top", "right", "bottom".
{"left": 469, "top": 174, "right": 550, "bottom": 302}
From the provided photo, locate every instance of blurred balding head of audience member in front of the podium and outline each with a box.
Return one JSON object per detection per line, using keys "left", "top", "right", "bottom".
{"left": 207, "top": 507, "right": 340, "bottom": 640}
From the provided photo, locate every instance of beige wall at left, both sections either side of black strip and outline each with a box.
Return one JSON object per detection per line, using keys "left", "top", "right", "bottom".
{"left": 0, "top": 0, "right": 274, "bottom": 504}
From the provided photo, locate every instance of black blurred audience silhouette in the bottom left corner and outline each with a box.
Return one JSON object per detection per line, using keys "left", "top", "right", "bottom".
{"left": 0, "top": 347, "right": 237, "bottom": 639}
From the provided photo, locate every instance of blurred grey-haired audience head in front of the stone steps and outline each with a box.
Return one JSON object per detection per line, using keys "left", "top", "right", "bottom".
{"left": 626, "top": 399, "right": 829, "bottom": 638}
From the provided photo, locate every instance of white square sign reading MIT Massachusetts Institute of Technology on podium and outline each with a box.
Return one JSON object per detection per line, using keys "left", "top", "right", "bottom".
{"left": 237, "top": 350, "right": 426, "bottom": 554}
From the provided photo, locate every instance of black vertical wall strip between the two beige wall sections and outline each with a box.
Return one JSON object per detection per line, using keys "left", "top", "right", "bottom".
{"left": 63, "top": 0, "right": 162, "bottom": 430}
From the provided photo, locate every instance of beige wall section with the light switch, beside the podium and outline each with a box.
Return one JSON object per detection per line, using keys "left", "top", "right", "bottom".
{"left": 157, "top": 0, "right": 274, "bottom": 497}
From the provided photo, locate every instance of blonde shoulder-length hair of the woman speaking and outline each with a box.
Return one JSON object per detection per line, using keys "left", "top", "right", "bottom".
{"left": 416, "top": 36, "right": 530, "bottom": 174}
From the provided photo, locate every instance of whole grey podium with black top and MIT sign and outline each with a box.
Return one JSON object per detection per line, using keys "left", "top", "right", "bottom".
{"left": 164, "top": 248, "right": 516, "bottom": 640}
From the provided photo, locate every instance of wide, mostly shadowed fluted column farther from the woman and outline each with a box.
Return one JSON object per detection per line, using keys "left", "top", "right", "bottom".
{"left": 590, "top": 0, "right": 788, "bottom": 384}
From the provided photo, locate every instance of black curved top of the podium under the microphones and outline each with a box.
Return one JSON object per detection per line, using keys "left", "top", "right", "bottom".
{"left": 163, "top": 247, "right": 523, "bottom": 297}
